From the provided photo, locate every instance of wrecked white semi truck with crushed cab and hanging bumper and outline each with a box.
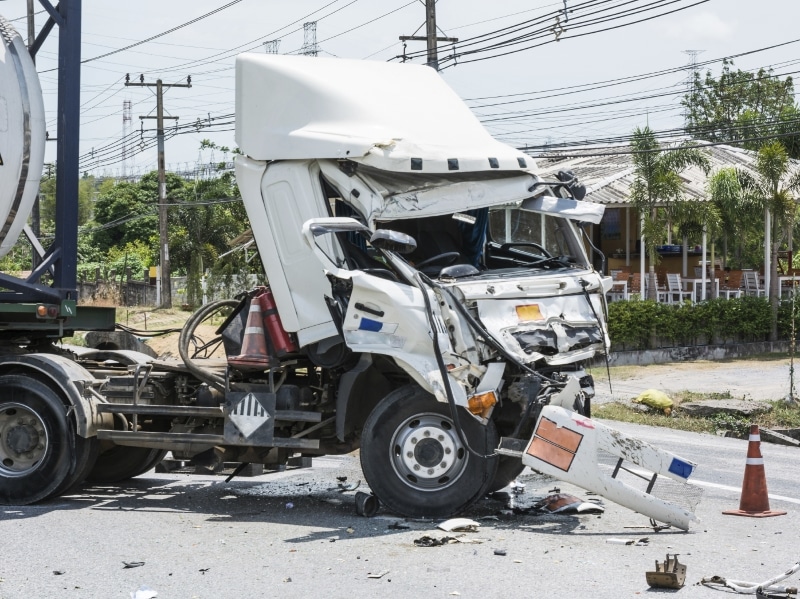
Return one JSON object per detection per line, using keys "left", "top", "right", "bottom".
{"left": 0, "top": 15, "right": 693, "bottom": 528}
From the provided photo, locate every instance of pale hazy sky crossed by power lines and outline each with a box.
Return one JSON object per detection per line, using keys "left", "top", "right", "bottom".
{"left": 0, "top": 0, "right": 800, "bottom": 176}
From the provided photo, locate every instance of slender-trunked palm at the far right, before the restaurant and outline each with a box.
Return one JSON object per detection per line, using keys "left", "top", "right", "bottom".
{"left": 738, "top": 140, "right": 800, "bottom": 341}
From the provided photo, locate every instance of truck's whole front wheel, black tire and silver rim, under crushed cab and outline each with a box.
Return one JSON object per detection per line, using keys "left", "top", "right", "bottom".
{"left": 361, "top": 385, "right": 498, "bottom": 518}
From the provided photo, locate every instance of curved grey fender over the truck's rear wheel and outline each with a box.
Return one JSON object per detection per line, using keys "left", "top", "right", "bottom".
{"left": 0, "top": 354, "right": 103, "bottom": 437}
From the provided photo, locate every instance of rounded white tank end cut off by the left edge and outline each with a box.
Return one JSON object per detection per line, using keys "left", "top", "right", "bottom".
{"left": 0, "top": 16, "right": 45, "bottom": 257}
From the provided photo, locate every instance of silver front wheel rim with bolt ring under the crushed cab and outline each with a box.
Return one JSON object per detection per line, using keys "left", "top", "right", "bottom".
{"left": 390, "top": 413, "right": 468, "bottom": 491}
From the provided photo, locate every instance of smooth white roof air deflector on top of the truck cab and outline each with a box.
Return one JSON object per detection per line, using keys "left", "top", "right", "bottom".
{"left": 236, "top": 53, "right": 535, "bottom": 174}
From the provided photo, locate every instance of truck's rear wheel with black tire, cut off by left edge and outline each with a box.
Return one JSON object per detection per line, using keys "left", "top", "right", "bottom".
{"left": 0, "top": 374, "right": 76, "bottom": 505}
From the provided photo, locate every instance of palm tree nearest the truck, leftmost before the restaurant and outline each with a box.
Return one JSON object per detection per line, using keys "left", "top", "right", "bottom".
{"left": 630, "top": 127, "right": 709, "bottom": 299}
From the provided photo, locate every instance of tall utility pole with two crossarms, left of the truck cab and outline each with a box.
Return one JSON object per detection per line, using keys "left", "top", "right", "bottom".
{"left": 125, "top": 74, "right": 192, "bottom": 308}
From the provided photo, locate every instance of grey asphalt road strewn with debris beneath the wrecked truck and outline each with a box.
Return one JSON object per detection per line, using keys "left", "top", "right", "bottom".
{"left": 0, "top": 423, "right": 800, "bottom": 599}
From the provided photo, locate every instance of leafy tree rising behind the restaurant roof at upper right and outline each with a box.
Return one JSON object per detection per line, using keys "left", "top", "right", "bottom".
{"left": 681, "top": 60, "right": 800, "bottom": 158}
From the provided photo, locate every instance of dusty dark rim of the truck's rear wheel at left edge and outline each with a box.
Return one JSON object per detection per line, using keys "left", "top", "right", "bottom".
{"left": 0, "top": 403, "right": 48, "bottom": 477}
